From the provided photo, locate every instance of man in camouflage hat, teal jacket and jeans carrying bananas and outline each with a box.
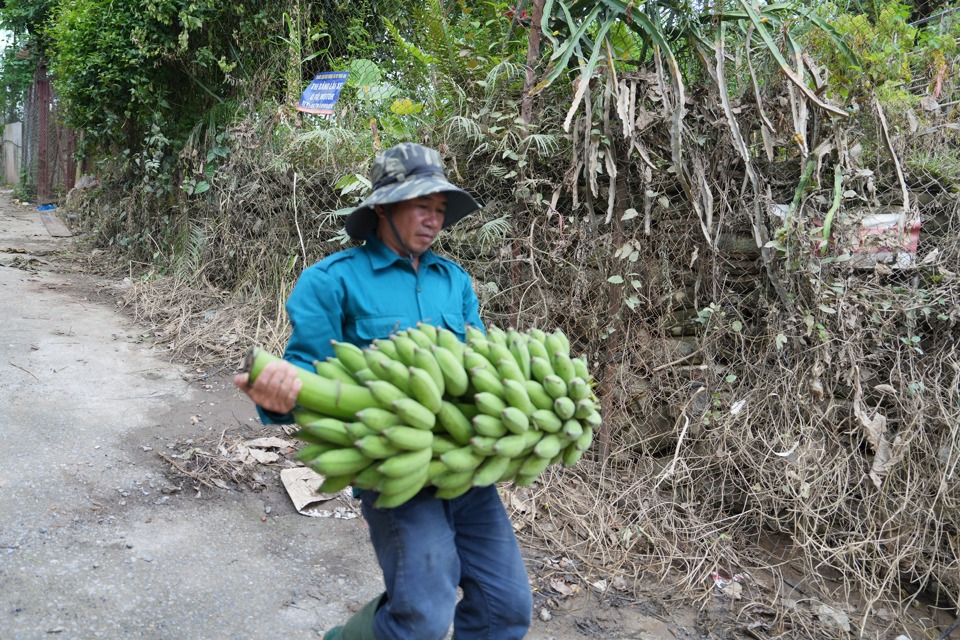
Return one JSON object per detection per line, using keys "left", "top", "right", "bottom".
{"left": 235, "top": 143, "right": 532, "bottom": 640}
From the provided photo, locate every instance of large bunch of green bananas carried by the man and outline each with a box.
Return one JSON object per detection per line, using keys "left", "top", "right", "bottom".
{"left": 246, "top": 323, "right": 601, "bottom": 508}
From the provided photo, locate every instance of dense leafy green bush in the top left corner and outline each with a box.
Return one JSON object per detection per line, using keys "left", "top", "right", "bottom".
{"left": 44, "top": 0, "right": 276, "bottom": 159}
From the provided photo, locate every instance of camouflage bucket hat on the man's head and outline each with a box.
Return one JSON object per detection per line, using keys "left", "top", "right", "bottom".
{"left": 344, "top": 142, "right": 481, "bottom": 240}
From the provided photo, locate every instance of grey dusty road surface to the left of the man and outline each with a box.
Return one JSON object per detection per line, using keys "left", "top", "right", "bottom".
{"left": 0, "top": 193, "right": 688, "bottom": 640}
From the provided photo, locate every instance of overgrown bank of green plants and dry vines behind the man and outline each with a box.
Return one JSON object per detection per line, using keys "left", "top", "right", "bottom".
{"left": 3, "top": 0, "right": 960, "bottom": 637}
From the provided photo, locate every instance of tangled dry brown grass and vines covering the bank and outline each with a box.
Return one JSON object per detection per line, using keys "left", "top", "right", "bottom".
{"left": 63, "top": 67, "right": 960, "bottom": 638}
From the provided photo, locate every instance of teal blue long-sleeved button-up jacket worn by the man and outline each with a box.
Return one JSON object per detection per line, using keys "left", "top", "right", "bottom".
{"left": 260, "top": 236, "right": 483, "bottom": 424}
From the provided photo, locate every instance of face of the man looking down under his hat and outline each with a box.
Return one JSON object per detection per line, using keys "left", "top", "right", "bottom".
{"left": 376, "top": 193, "right": 447, "bottom": 256}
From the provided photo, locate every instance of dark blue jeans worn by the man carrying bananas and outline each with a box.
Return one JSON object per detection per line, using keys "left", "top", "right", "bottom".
{"left": 360, "top": 486, "right": 533, "bottom": 640}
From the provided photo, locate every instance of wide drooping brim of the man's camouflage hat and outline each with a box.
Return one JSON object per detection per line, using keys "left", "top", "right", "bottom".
{"left": 344, "top": 176, "right": 483, "bottom": 240}
